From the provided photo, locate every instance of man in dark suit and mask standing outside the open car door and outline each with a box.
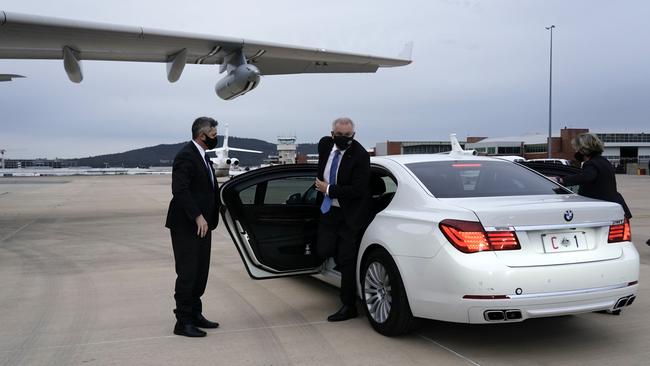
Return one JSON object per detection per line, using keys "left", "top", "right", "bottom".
{"left": 165, "top": 117, "right": 219, "bottom": 337}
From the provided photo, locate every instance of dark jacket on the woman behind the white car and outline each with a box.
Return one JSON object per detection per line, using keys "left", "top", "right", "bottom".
{"left": 562, "top": 155, "right": 632, "bottom": 218}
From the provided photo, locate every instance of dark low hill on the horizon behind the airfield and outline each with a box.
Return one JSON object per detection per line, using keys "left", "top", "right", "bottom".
{"left": 68, "top": 136, "right": 317, "bottom": 168}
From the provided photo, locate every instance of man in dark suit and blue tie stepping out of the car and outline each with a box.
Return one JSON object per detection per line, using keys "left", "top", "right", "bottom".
{"left": 315, "top": 118, "right": 370, "bottom": 322}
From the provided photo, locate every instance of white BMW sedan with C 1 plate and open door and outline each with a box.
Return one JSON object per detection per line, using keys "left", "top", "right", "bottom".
{"left": 221, "top": 154, "right": 639, "bottom": 335}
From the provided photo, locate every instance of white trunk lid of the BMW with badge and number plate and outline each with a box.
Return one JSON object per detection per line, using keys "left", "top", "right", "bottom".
{"left": 444, "top": 195, "right": 623, "bottom": 267}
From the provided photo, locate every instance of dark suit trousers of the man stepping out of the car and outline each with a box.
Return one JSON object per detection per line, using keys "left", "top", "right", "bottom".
{"left": 316, "top": 206, "right": 359, "bottom": 306}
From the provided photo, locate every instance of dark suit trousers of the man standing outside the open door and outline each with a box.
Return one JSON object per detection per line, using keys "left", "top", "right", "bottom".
{"left": 170, "top": 229, "right": 212, "bottom": 323}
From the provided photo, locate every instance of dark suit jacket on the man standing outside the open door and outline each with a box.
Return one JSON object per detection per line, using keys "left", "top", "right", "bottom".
{"left": 165, "top": 141, "right": 219, "bottom": 232}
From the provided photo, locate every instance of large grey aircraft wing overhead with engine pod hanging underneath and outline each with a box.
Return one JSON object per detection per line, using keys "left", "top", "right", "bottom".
{"left": 0, "top": 11, "right": 411, "bottom": 99}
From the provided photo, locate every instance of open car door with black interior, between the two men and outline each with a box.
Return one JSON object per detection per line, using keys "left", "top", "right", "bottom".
{"left": 220, "top": 164, "right": 322, "bottom": 279}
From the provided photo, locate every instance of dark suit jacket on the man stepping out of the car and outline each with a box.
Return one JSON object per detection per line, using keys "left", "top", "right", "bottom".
{"left": 318, "top": 136, "right": 370, "bottom": 229}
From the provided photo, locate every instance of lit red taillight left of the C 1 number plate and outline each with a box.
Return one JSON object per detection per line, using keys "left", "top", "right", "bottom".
{"left": 439, "top": 220, "right": 521, "bottom": 253}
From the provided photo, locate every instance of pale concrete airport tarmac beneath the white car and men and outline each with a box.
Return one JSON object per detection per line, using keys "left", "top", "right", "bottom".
{"left": 0, "top": 176, "right": 650, "bottom": 366}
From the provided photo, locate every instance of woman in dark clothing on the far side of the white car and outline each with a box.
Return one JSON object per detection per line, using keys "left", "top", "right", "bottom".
{"left": 558, "top": 133, "right": 632, "bottom": 219}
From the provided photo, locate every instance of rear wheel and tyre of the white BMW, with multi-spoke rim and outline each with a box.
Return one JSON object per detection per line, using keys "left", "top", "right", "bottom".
{"left": 361, "top": 250, "right": 415, "bottom": 336}
